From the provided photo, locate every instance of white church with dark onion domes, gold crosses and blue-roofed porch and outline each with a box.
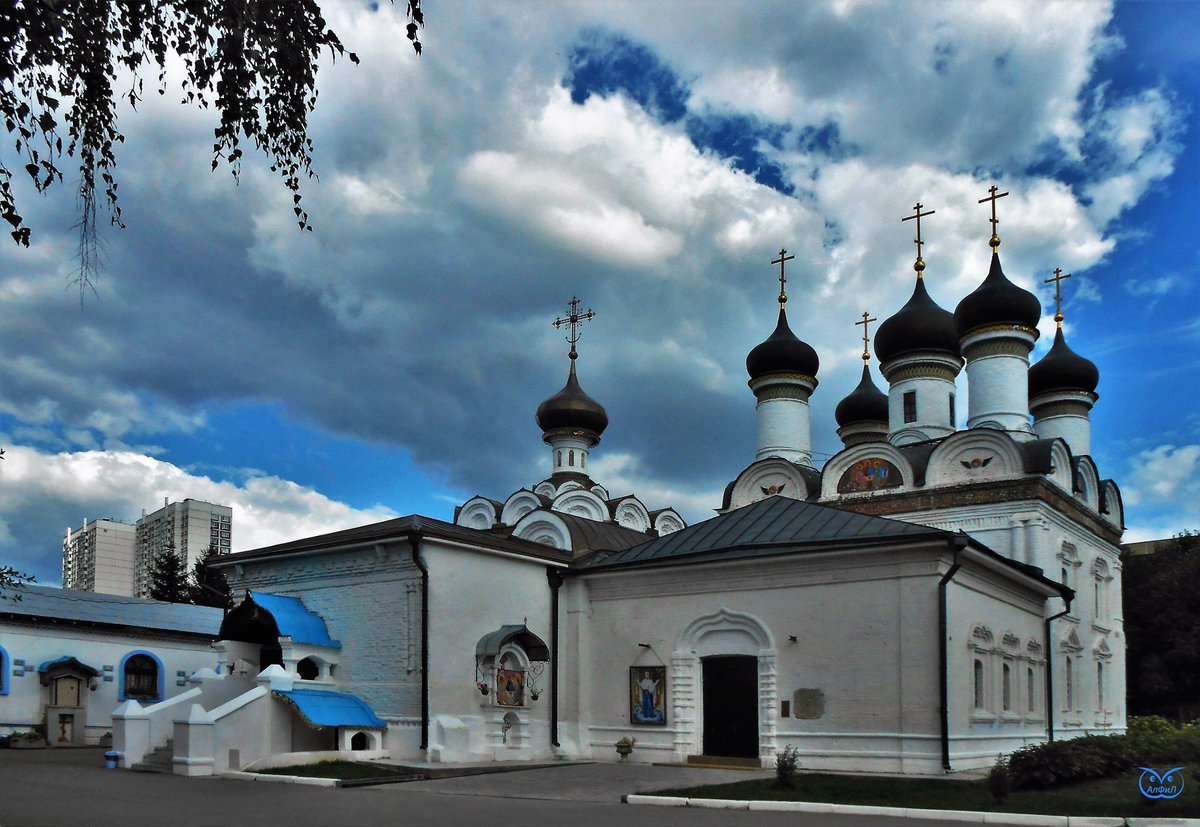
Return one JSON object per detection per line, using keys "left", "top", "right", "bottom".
{"left": 114, "top": 205, "right": 1126, "bottom": 774}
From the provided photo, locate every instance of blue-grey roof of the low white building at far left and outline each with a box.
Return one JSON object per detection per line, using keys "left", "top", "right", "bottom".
{"left": 0, "top": 586, "right": 222, "bottom": 637}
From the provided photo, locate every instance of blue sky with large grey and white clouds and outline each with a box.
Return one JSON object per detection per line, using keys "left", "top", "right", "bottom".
{"left": 0, "top": 1, "right": 1200, "bottom": 583}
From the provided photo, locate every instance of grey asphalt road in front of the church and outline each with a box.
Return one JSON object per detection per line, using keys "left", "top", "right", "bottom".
{"left": 0, "top": 749, "right": 984, "bottom": 827}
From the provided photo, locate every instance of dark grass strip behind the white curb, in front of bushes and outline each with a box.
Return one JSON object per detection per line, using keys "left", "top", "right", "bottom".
{"left": 654, "top": 766, "right": 1200, "bottom": 817}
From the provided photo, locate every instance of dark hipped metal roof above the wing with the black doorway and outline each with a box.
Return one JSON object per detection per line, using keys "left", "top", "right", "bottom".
{"left": 587, "top": 496, "right": 954, "bottom": 570}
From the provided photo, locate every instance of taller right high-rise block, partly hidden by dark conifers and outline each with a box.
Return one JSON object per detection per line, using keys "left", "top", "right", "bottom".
{"left": 134, "top": 497, "right": 233, "bottom": 598}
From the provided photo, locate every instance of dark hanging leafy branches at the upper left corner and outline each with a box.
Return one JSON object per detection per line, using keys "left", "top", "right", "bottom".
{"left": 0, "top": 0, "right": 424, "bottom": 289}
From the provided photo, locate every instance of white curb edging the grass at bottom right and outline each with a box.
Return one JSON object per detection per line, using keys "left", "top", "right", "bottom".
{"left": 623, "top": 795, "right": 1200, "bottom": 827}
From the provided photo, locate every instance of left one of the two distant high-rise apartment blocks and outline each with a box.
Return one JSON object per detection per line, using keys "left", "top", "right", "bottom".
{"left": 62, "top": 517, "right": 137, "bottom": 597}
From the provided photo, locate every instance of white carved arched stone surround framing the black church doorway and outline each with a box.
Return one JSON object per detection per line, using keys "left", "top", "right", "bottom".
{"left": 670, "top": 605, "right": 779, "bottom": 766}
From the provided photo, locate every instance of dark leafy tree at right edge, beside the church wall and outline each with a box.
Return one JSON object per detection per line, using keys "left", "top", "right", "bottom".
{"left": 1122, "top": 532, "right": 1200, "bottom": 720}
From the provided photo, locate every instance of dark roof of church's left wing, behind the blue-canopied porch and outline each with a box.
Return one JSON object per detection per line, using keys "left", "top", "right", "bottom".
{"left": 212, "top": 515, "right": 564, "bottom": 568}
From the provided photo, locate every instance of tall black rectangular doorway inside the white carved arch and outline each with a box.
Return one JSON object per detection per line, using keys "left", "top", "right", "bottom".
{"left": 700, "top": 655, "right": 758, "bottom": 759}
